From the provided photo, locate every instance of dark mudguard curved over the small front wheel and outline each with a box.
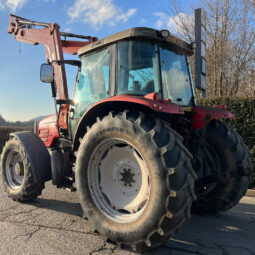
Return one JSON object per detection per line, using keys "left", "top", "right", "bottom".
{"left": 10, "top": 131, "right": 51, "bottom": 184}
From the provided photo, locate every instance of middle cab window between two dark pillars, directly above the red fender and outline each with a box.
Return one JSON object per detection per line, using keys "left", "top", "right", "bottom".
{"left": 117, "top": 40, "right": 160, "bottom": 96}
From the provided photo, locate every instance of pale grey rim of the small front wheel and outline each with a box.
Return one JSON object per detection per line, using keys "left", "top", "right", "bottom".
{"left": 4, "top": 151, "right": 24, "bottom": 189}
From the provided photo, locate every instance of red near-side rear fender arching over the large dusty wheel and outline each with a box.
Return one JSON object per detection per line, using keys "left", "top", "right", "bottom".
{"left": 73, "top": 93, "right": 184, "bottom": 151}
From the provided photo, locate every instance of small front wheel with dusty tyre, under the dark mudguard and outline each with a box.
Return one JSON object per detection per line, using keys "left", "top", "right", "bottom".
{"left": 1, "top": 137, "right": 44, "bottom": 202}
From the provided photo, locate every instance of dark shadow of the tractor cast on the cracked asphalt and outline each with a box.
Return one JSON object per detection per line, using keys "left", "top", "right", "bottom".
{"left": 26, "top": 193, "right": 255, "bottom": 255}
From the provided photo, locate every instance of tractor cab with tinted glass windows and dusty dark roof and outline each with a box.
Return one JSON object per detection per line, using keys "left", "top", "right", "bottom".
{"left": 72, "top": 28, "right": 195, "bottom": 134}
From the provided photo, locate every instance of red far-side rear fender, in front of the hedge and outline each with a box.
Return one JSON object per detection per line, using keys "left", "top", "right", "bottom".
{"left": 191, "top": 105, "right": 235, "bottom": 130}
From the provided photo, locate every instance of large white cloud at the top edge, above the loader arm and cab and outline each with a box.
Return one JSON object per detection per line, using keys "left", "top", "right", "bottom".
{"left": 67, "top": 0, "right": 137, "bottom": 29}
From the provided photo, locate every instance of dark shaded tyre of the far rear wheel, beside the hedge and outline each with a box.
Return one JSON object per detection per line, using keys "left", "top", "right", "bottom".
{"left": 193, "top": 120, "right": 252, "bottom": 214}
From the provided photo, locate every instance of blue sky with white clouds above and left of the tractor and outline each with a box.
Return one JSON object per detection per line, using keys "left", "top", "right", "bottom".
{"left": 0, "top": 0, "right": 189, "bottom": 121}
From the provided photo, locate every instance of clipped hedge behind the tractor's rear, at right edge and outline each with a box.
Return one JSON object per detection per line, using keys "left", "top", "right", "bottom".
{"left": 197, "top": 97, "right": 255, "bottom": 188}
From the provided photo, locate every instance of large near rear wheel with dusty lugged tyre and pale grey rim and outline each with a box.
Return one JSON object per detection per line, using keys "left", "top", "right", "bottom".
{"left": 75, "top": 112, "right": 196, "bottom": 251}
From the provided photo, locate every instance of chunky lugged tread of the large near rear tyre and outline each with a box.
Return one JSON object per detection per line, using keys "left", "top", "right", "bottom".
{"left": 78, "top": 111, "right": 197, "bottom": 251}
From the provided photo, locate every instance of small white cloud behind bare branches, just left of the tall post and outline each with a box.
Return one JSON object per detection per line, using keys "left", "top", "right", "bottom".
{"left": 154, "top": 12, "right": 194, "bottom": 34}
